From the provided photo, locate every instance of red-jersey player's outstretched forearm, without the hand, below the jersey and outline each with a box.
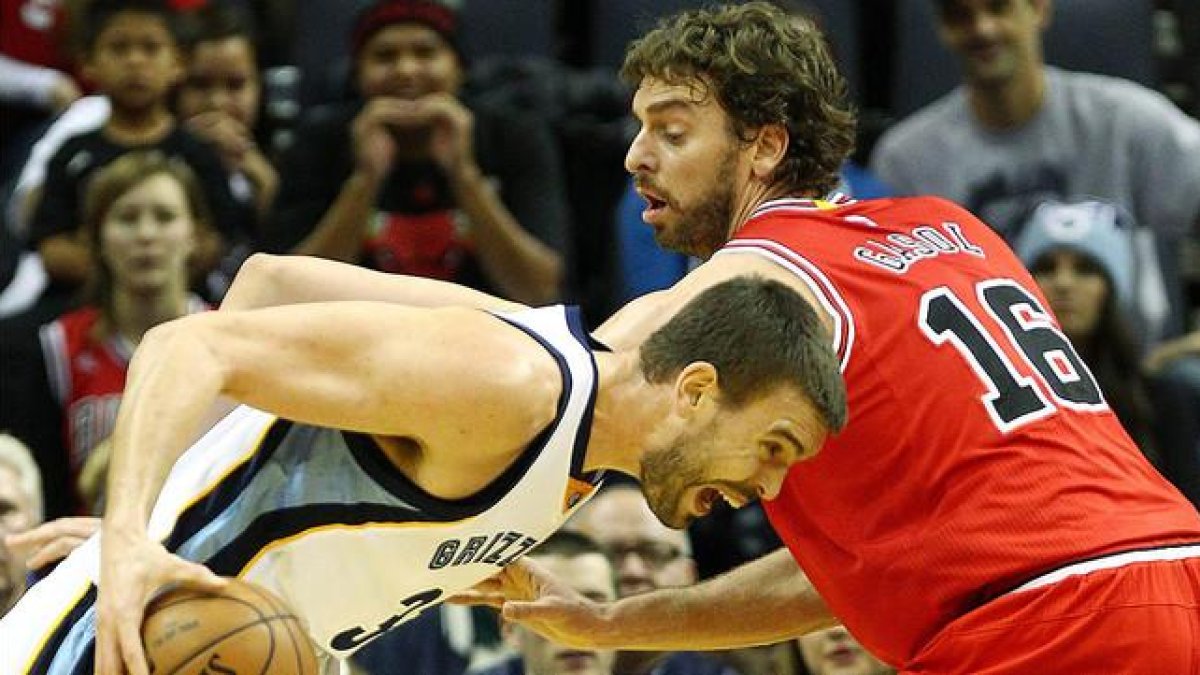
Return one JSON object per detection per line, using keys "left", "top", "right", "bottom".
{"left": 598, "top": 549, "right": 836, "bottom": 651}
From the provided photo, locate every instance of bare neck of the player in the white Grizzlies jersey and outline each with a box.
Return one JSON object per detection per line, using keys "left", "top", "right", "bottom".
{"left": 583, "top": 351, "right": 670, "bottom": 476}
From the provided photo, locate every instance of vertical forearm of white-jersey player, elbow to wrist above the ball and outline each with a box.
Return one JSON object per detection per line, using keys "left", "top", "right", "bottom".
{"left": 104, "top": 318, "right": 224, "bottom": 536}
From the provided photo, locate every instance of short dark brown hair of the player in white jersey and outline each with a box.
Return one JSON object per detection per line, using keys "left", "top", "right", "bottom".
{"left": 640, "top": 275, "right": 846, "bottom": 431}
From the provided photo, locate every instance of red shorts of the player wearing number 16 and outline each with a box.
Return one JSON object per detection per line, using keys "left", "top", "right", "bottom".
{"left": 900, "top": 550, "right": 1200, "bottom": 675}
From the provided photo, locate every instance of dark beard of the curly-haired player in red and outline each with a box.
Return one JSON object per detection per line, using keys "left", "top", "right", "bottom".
{"left": 654, "top": 148, "right": 737, "bottom": 259}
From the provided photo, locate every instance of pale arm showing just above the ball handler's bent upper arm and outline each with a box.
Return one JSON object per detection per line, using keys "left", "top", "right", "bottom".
{"left": 221, "top": 253, "right": 524, "bottom": 311}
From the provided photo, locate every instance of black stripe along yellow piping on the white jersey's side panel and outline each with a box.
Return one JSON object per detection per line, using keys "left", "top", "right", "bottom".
{"left": 204, "top": 499, "right": 445, "bottom": 577}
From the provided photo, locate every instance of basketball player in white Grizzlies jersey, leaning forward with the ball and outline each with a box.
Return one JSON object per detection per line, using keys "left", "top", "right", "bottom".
{"left": 0, "top": 270, "right": 845, "bottom": 675}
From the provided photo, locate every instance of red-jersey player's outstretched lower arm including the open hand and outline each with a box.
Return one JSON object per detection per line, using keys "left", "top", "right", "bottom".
{"left": 467, "top": 549, "right": 838, "bottom": 651}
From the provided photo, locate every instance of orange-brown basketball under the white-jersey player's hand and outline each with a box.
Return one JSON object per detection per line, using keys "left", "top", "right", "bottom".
{"left": 142, "top": 571, "right": 317, "bottom": 675}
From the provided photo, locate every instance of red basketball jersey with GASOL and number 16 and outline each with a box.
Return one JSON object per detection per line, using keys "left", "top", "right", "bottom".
{"left": 718, "top": 198, "right": 1200, "bottom": 663}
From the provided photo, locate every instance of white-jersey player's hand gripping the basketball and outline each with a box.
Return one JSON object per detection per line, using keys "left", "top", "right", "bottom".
{"left": 96, "top": 528, "right": 227, "bottom": 675}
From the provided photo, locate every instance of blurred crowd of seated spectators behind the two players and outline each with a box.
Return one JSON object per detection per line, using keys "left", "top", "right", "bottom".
{"left": 0, "top": 0, "right": 1200, "bottom": 675}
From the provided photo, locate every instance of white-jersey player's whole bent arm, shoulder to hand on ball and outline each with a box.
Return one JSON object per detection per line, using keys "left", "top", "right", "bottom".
{"left": 96, "top": 301, "right": 560, "bottom": 675}
